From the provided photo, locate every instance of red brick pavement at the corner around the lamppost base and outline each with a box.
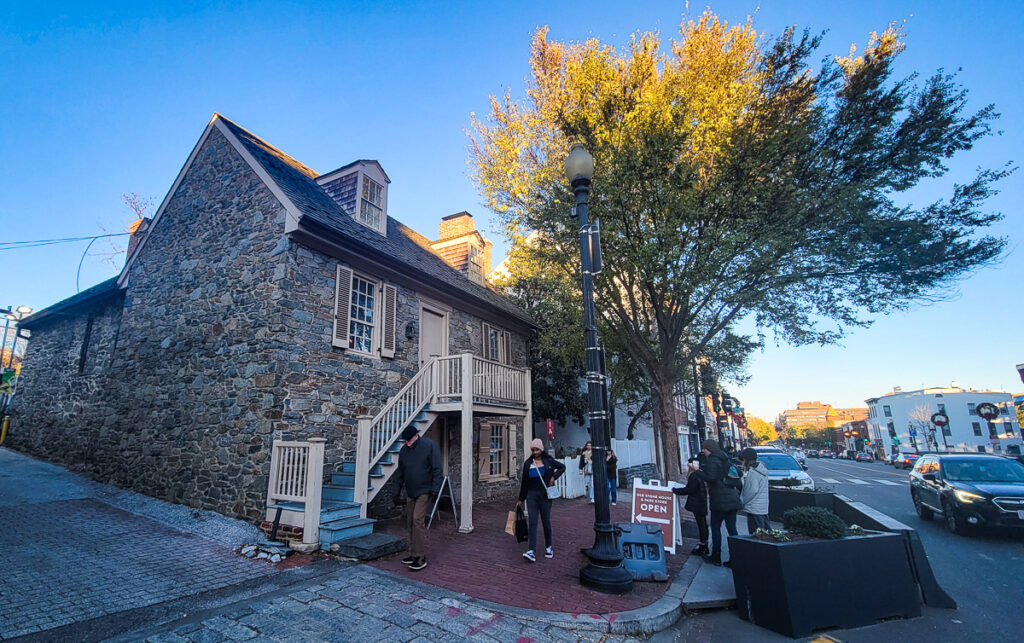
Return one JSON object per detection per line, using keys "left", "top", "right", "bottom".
{"left": 371, "top": 491, "right": 692, "bottom": 613}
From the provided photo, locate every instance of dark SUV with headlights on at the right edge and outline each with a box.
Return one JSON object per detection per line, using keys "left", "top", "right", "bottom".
{"left": 910, "top": 454, "right": 1024, "bottom": 533}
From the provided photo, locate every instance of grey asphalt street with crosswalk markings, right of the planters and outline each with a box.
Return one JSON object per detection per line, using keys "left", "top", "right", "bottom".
{"left": 654, "top": 459, "right": 1024, "bottom": 643}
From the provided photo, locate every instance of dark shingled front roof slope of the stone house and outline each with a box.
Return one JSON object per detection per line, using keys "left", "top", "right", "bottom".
{"left": 214, "top": 115, "right": 537, "bottom": 327}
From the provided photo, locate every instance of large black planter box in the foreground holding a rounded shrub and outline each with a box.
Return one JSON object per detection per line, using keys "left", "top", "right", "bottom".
{"left": 729, "top": 532, "right": 921, "bottom": 638}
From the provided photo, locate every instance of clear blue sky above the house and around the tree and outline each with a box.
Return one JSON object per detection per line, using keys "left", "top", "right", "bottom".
{"left": 0, "top": 0, "right": 1024, "bottom": 418}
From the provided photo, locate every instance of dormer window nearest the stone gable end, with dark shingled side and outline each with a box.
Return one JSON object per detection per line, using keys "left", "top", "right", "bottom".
{"left": 316, "top": 161, "right": 391, "bottom": 235}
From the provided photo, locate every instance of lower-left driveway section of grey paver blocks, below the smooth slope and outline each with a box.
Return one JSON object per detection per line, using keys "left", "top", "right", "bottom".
{"left": 0, "top": 498, "right": 276, "bottom": 639}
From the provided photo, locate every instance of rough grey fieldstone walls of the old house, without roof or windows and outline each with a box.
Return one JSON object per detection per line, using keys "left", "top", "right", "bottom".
{"left": 7, "top": 128, "right": 527, "bottom": 521}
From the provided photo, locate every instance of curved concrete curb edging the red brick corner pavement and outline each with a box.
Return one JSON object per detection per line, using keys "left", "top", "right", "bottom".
{"left": 362, "top": 556, "right": 700, "bottom": 636}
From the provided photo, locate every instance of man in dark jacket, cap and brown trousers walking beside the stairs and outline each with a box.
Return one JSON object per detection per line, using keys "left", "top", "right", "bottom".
{"left": 394, "top": 426, "right": 444, "bottom": 571}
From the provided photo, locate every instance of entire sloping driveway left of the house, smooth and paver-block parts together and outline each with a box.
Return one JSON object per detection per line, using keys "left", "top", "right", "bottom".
{"left": 0, "top": 448, "right": 295, "bottom": 639}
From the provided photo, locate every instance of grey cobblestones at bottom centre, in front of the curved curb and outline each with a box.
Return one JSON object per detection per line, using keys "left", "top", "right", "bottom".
{"left": 121, "top": 565, "right": 636, "bottom": 643}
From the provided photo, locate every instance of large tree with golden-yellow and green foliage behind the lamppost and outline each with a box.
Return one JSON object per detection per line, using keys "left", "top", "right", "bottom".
{"left": 471, "top": 12, "right": 1009, "bottom": 477}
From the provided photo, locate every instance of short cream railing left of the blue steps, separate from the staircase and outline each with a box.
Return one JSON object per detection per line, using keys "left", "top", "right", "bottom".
{"left": 266, "top": 437, "right": 327, "bottom": 548}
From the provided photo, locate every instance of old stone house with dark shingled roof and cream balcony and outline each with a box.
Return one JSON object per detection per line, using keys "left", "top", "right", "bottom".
{"left": 14, "top": 115, "right": 536, "bottom": 531}
